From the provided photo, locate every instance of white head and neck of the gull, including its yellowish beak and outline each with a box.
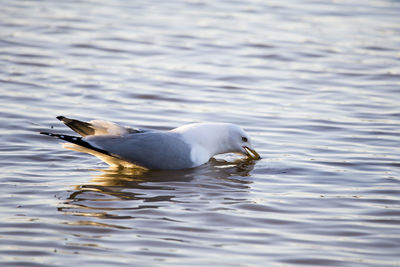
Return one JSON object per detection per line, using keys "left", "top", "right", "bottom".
{"left": 172, "top": 122, "right": 260, "bottom": 162}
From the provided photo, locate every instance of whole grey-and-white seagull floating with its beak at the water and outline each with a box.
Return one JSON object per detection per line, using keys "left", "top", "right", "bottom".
{"left": 40, "top": 116, "right": 261, "bottom": 170}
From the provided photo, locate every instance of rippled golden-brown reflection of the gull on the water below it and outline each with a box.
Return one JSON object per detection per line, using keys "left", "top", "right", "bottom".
{"left": 58, "top": 159, "right": 255, "bottom": 224}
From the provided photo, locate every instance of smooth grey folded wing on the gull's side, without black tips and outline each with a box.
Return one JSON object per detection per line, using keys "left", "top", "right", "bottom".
{"left": 85, "top": 131, "right": 193, "bottom": 169}
